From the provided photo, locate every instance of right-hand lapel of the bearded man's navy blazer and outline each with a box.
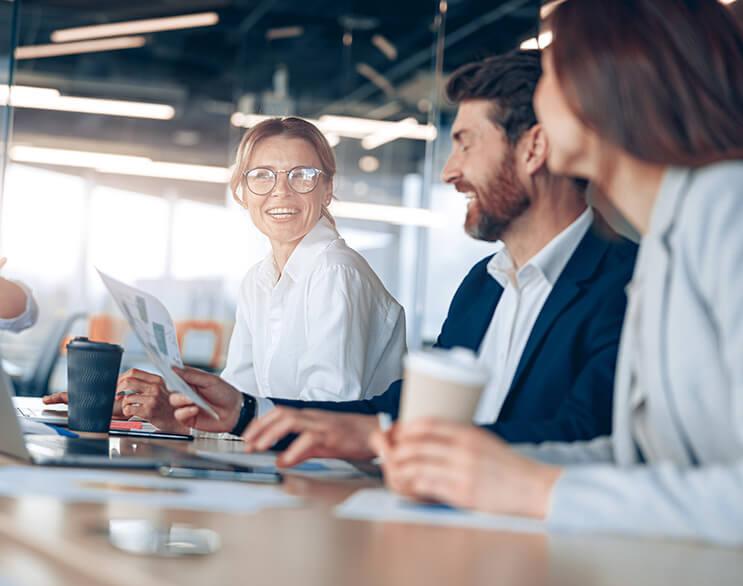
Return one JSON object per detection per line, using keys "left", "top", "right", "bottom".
{"left": 506, "top": 223, "right": 609, "bottom": 401}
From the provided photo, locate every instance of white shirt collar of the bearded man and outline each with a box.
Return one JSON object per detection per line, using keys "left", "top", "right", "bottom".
{"left": 488, "top": 206, "right": 593, "bottom": 288}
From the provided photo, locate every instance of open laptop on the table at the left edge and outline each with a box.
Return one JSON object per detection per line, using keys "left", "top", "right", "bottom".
{"left": 0, "top": 358, "right": 218, "bottom": 470}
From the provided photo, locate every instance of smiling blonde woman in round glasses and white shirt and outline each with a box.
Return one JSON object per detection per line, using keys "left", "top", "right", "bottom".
{"left": 205, "top": 117, "right": 405, "bottom": 405}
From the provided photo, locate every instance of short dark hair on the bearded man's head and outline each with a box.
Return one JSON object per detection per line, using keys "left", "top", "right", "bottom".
{"left": 446, "top": 50, "right": 542, "bottom": 144}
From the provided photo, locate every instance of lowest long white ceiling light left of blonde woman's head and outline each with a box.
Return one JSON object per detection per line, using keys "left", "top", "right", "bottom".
{"left": 10, "top": 145, "right": 231, "bottom": 184}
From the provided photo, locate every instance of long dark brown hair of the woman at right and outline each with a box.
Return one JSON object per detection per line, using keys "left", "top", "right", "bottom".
{"left": 547, "top": 0, "right": 743, "bottom": 167}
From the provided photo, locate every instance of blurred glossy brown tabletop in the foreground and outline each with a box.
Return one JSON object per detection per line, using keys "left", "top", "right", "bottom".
{"left": 0, "top": 440, "right": 743, "bottom": 586}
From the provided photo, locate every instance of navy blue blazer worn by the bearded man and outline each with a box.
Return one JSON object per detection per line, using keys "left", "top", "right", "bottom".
{"left": 273, "top": 222, "right": 637, "bottom": 443}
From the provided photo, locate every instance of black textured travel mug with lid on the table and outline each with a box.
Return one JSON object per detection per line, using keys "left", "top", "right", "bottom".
{"left": 67, "top": 337, "right": 124, "bottom": 433}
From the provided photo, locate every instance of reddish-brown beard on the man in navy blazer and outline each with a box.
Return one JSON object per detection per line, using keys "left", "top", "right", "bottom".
{"left": 464, "top": 152, "right": 531, "bottom": 242}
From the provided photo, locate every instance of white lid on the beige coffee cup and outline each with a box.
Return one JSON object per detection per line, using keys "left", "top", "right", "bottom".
{"left": 404, "top": 346, "right": 490, "bottom": 386}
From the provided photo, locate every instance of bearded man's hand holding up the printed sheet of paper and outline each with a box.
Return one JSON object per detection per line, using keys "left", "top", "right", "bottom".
{"left": 170, "top": 368, "right": 243, "bottom": 432}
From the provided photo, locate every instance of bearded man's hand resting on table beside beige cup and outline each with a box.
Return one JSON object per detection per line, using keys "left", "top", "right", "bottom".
{"left": 243, "top": 407, "right": 377, "bottom": 467}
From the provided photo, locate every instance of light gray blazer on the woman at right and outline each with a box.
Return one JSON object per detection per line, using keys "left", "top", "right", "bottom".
{"left": 520, "top": 161, "right": 743, "bottom": 544}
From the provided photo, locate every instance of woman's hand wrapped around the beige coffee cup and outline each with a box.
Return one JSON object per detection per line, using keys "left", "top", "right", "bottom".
{"left": 371, "top": 419, "right": 561, "bottom": 519}
